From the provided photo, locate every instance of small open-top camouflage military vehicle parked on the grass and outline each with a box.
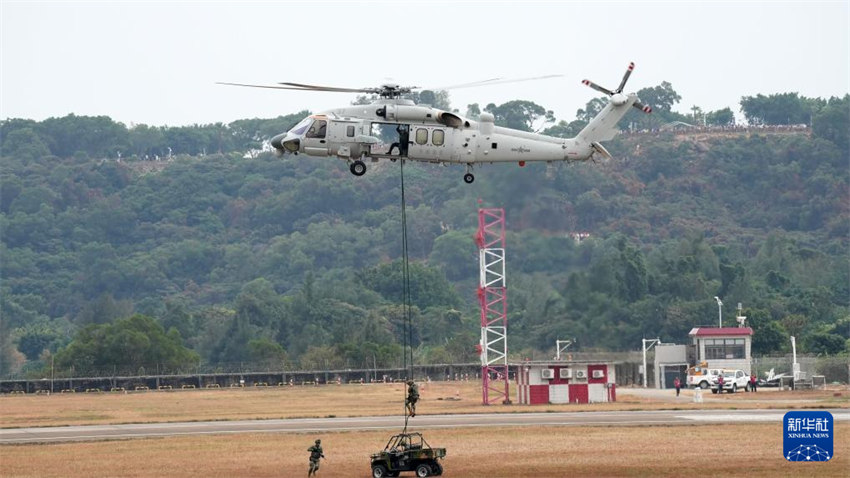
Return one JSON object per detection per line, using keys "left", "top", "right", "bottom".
{"left": 372, "top": 433, "right": 446, "bottom": 478}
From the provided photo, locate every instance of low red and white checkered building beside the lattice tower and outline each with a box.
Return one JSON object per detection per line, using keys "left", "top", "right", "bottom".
{"left": 516, "top": 362, "right": 617, "bottom": 405}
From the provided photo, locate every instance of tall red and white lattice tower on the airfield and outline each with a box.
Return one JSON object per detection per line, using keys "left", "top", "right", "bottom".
{"left": 475, "top": 208, "right": 510, "bottom": 405}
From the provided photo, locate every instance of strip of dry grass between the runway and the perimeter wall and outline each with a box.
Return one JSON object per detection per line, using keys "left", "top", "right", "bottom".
{"left": 0, "top": 382, "right": 850, "bottom": 428}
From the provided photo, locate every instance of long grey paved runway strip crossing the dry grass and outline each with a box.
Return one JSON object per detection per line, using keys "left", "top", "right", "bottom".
{"left": 0, "top": 409, "right": 850, "bottom": 444}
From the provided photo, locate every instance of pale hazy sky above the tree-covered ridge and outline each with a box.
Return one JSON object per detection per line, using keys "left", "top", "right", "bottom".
{"left": 0, "top": 0, "right": 850, "bottom": 125}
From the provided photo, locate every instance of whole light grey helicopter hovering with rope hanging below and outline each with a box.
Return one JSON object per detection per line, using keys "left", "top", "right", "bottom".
{"left": 220, "top": 62, "right": 652, "bottom": 184}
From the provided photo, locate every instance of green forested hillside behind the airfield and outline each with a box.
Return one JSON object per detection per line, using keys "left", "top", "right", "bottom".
{"left": 0, "top": 93, "right": 850, "bottom": 373}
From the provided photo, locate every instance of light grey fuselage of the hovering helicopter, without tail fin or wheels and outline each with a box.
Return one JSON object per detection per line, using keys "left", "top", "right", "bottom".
{"left": 272, "top": 99, "right": 593, "bottom": 165}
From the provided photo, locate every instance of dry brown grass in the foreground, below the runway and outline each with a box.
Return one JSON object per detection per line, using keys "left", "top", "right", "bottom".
{"left": 0, "top": 422, "right": 850, "bottom": 478}
